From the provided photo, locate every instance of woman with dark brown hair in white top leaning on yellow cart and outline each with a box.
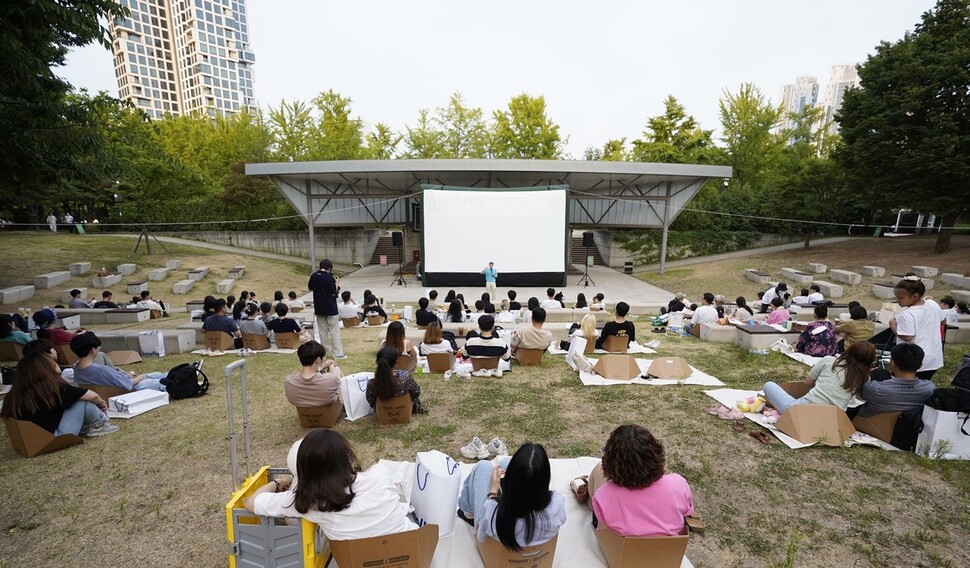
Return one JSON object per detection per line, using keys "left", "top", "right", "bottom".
{"left": 244, "top": 428, "right": 418, "bottom": 540}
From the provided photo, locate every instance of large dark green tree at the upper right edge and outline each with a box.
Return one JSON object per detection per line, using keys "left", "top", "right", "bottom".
{"left": 836, "top": 0, "right": 970, "bottom": 253}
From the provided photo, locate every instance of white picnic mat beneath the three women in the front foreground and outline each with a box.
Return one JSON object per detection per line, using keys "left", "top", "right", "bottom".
{"left": 370, "top": 457, "right": 694, "bottom": 568}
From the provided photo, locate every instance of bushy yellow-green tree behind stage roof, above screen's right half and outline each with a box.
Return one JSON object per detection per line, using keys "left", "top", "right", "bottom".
{"left": 492, "top": 93, "right": 565, "bottom": 160}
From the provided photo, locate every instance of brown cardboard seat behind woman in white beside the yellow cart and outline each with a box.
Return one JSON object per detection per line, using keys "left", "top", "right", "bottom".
{"left": 330, "top": 525, "right": 438, "bottom": 568}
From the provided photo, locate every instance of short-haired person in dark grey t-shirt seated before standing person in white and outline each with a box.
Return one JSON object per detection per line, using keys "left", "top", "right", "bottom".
{"left": 857, "top": 342, "right": 936, "bottom": 417}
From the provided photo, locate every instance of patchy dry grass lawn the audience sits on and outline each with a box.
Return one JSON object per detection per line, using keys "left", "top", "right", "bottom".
{"left": 0, "top": 234, "right": 970, "bottom": 567}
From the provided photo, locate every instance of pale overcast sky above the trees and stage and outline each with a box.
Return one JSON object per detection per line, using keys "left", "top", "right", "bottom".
{"left": 59, "top": 0, "right": 935, "bottom": 159}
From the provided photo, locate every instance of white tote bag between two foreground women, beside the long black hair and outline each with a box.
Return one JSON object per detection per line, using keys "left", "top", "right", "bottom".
{"left": 411, "top": 450, "right": 461, "bottom": 538}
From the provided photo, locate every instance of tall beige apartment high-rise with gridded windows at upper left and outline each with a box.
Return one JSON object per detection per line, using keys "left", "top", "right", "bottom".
{"left": 111, "top": 0, "right": 256, "bottom": 118}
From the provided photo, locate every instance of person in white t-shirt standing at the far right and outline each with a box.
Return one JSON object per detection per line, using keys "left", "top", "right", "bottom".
{"left": 889, "top": 274, "right": 946, "bottom": 380}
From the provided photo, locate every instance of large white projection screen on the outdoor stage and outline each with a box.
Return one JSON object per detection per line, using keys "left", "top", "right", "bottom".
{"left": 421, "top": 186, "right": 569, "bottom": 287}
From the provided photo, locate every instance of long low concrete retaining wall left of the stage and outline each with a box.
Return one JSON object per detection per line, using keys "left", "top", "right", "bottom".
{"left": 174, "top": 229, "right": 385, "bottom": 266}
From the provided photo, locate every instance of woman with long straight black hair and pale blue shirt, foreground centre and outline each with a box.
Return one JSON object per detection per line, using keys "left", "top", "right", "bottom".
{"left": 458, "top": 442, "right": 566, "bottom": 551}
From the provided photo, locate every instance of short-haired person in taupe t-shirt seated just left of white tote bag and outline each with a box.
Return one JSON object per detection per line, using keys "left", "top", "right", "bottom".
{"left": 277, "top": 340, "right": 343, "bottom": 407}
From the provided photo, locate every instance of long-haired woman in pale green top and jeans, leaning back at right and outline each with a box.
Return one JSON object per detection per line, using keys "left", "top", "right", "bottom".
{"left": 764, "top": 341, "right": 876, "bottom": 413}
